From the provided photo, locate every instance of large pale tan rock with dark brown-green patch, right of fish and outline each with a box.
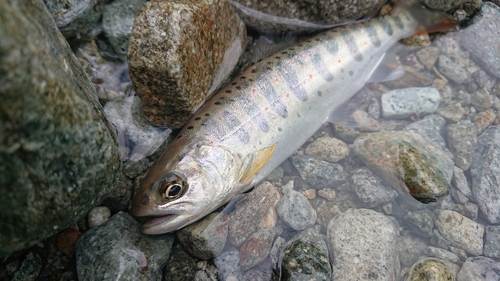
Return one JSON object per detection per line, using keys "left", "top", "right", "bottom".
{"left": 353, "top": 132, "right": 453, "bottom": 202}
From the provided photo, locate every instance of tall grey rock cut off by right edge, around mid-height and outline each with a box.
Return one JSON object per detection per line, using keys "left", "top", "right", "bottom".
{"left": 470, "top": 126, "right": 500, "bottom": 224}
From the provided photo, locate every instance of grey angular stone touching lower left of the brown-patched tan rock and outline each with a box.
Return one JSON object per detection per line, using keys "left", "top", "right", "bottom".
{"left": 349, "top": 167, "right": 398, "bottom": 207}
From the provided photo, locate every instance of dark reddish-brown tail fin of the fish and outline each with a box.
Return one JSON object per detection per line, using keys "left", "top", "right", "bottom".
{"left": 394, "top": 0, "right": 458, "bottom": 35}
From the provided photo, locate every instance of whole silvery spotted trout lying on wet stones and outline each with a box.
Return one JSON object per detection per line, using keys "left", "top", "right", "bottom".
{"left": 131, "top": 3, "right": 456, "bottom": 235}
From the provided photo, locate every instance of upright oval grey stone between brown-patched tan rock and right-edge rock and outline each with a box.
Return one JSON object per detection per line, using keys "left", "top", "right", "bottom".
{"left": 446, "top": 120, "right": 477, "bottom": 171}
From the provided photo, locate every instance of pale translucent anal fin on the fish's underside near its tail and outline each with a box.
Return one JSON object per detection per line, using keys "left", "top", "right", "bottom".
{"left": 366, "top": 52, "right": 405, "bottom": 83}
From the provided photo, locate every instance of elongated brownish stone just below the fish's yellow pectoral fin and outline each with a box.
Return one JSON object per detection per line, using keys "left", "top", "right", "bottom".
{"left": 229, "top": 182, "right": 280, "bottom": 246}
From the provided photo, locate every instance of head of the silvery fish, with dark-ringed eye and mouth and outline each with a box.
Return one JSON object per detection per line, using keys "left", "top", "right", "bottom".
{"left": 131, "top": 143, "right": 242, "bottom": 234}
